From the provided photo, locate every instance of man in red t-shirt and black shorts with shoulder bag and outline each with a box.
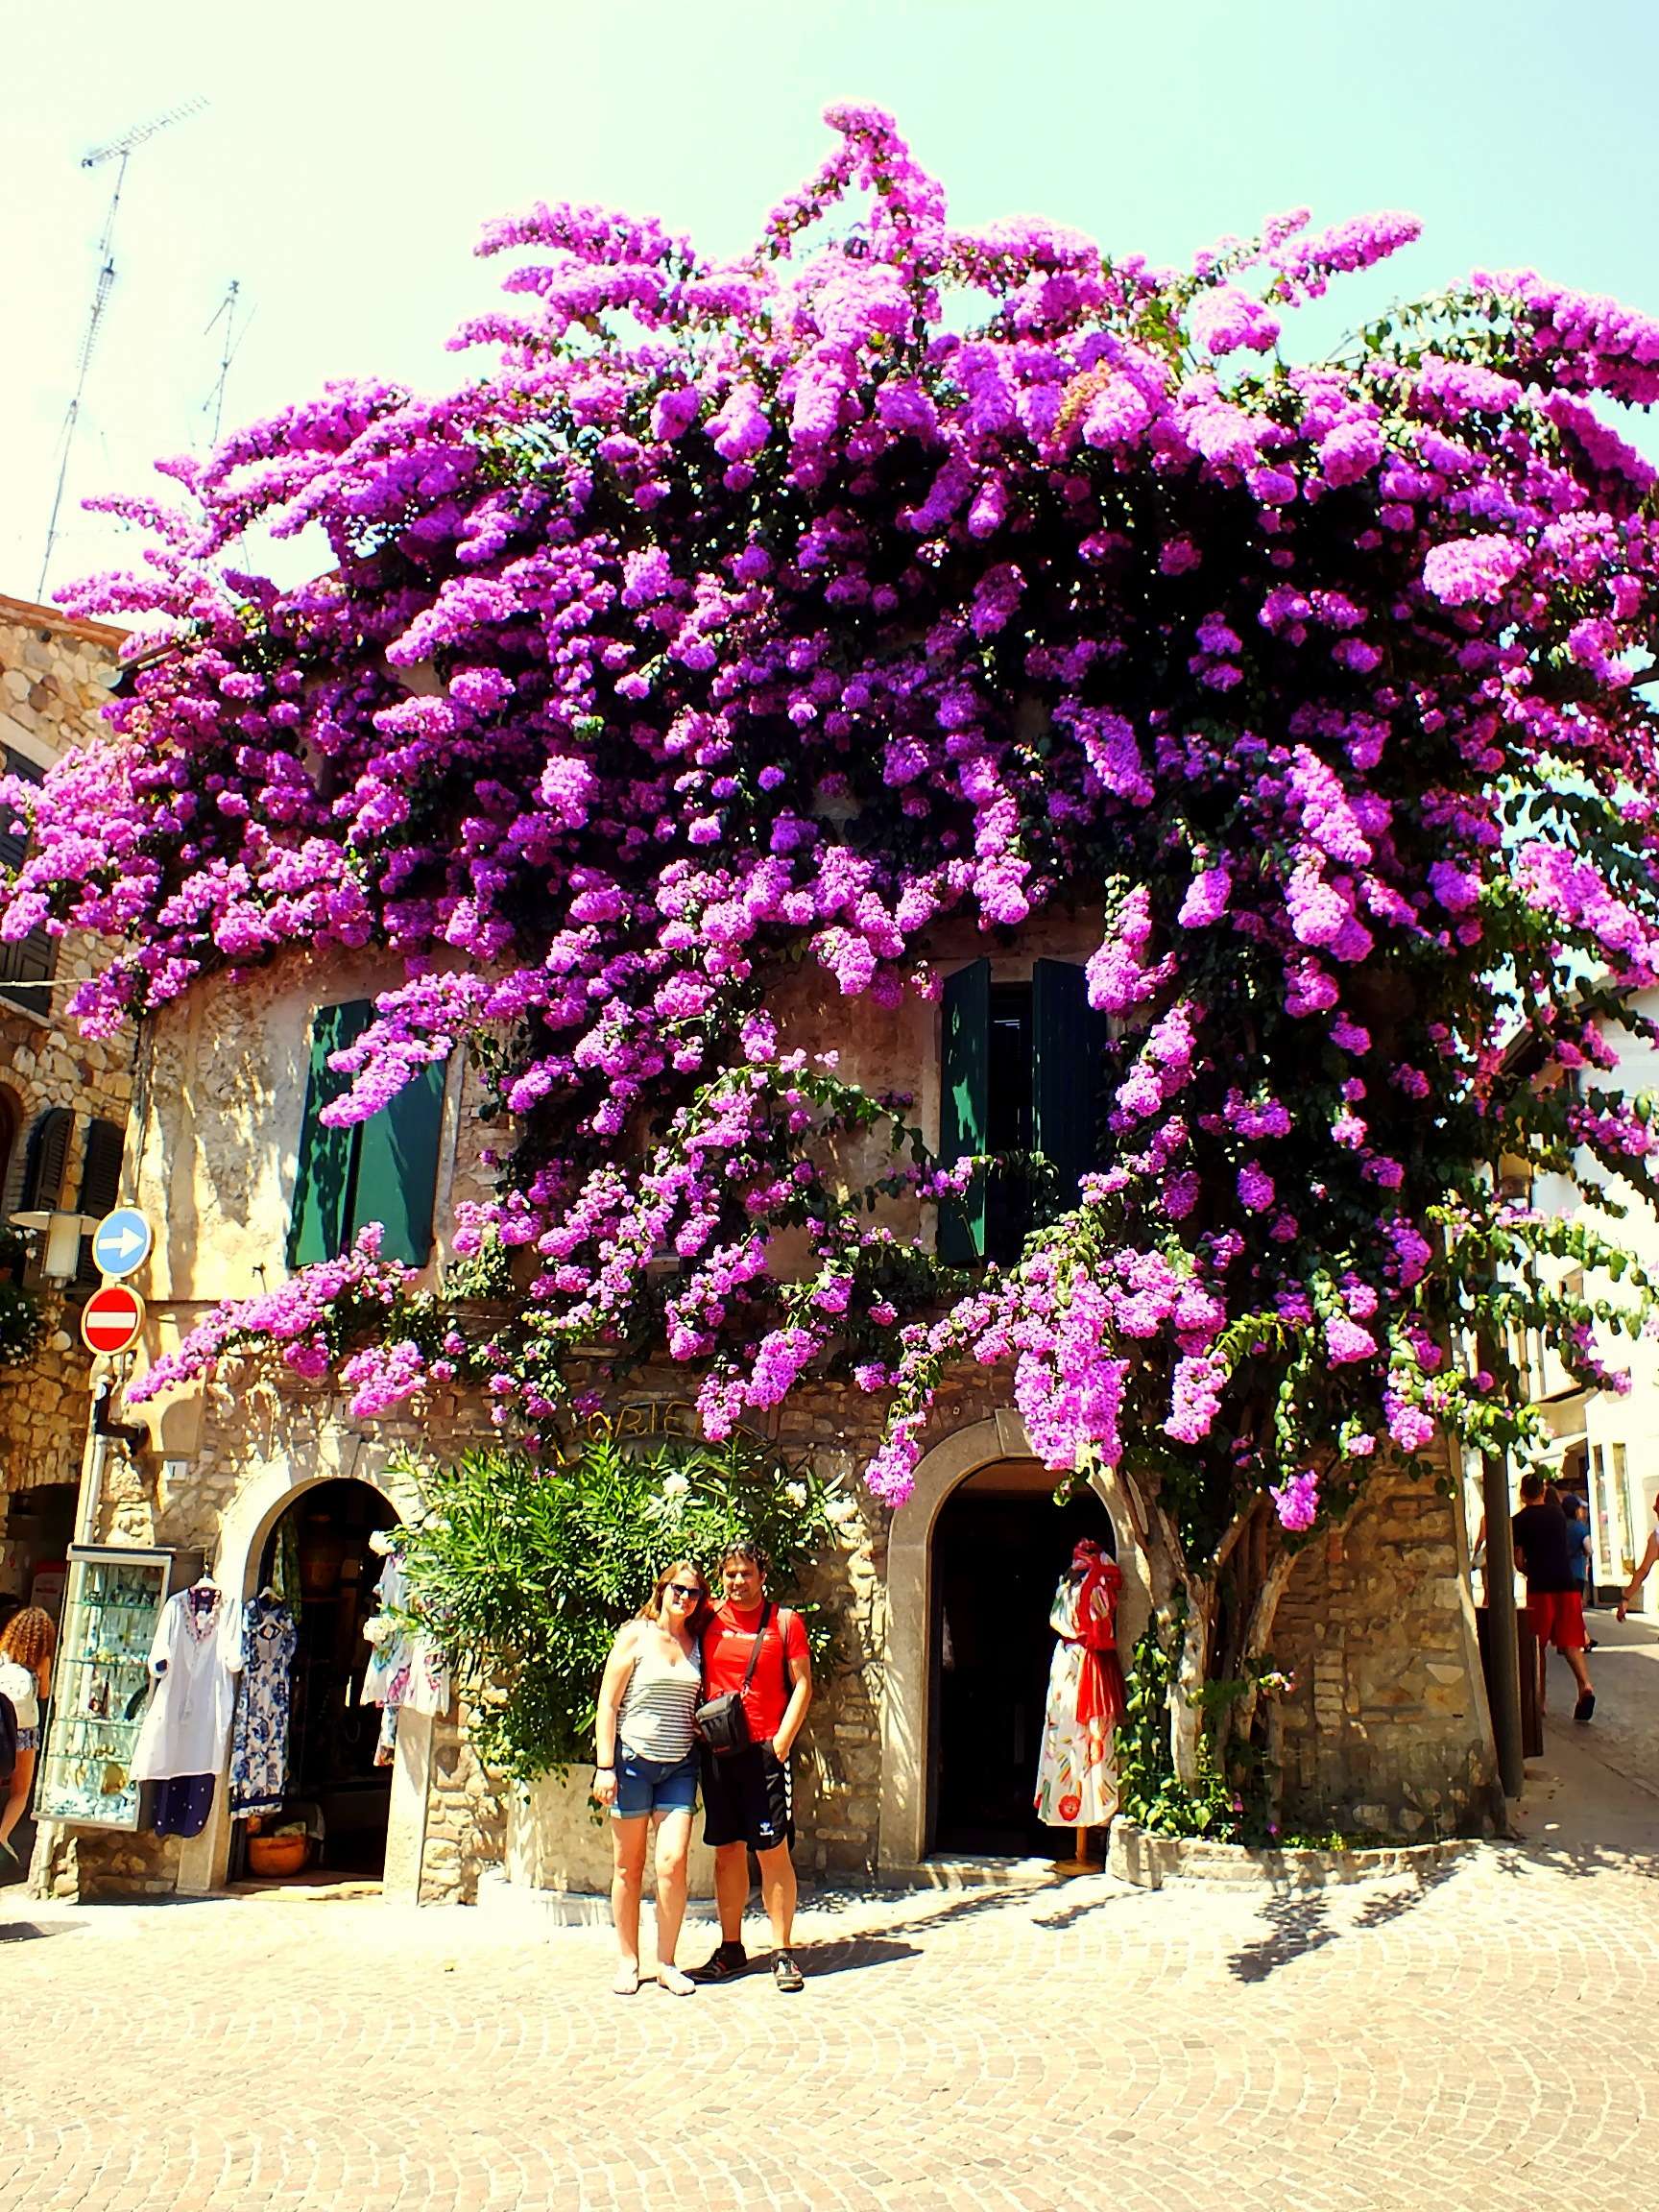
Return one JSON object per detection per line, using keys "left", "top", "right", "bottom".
{"left": 692, "top": 1544, "right": 812, "bottom": 1993}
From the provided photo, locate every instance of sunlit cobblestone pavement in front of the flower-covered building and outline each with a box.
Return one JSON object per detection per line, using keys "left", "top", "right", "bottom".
{"left": 0, "top": 1628, "right": 1659, "bottom": 2212}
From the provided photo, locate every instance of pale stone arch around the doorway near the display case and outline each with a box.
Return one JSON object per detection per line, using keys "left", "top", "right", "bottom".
{"left": 180, "top": 1442, "right": 434, "bottom": 1905}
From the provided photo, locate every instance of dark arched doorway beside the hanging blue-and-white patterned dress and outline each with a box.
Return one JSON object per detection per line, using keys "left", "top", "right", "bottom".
{"left": 230, "top": 1478, "right": 398, "bottom": 1878}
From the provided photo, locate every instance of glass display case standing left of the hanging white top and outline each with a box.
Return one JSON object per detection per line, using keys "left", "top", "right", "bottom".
{"left": 36, "top": 1544, "right": 202, "bottom": 1829}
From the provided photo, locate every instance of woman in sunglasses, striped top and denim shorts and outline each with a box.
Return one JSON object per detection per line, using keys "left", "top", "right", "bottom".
{"left": 592, "top": 1559, "right": 708, "bottom": 1998}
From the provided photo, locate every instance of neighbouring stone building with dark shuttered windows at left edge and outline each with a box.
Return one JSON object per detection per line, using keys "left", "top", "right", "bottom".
{"left": 0, "top": 597, "right": 132, "bottom": 1597}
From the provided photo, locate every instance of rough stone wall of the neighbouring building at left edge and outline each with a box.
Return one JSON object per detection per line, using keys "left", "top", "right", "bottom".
{"left": 0, "top": 597, "right": 132, "bottom": 1595}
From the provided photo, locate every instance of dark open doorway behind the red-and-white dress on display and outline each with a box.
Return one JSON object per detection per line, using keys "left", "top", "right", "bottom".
{"left": 929, "top": 1460, "right": 1118, "bottom": 1856}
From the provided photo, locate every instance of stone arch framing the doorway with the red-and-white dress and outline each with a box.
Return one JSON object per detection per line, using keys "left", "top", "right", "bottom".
{"left": 876, "top": 1411, "right": 1152, "bottom": 1869}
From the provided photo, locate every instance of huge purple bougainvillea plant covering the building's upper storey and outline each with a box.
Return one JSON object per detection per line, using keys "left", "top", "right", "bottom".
{"left": 0, "top": 108, "right": 1659, "bottom": 1795}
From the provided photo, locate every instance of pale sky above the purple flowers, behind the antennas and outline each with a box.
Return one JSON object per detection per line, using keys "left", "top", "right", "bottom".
{"left": 0, "top": 0, "right": 1659, "bottom": 599}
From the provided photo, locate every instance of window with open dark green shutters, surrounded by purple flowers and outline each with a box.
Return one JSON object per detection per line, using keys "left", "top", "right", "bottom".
{"left": 938, "top": 960, "right": 1106, "bottom": 1267}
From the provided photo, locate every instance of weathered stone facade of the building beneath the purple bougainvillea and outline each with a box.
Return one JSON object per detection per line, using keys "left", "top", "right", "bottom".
{"left": 36, "top": 898, "right": 1491, "bottom": 1900}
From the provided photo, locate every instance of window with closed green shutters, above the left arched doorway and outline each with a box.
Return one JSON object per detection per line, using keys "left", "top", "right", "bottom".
{"left": 288, "top": 998, "right": 445, "bottom": 1267}
